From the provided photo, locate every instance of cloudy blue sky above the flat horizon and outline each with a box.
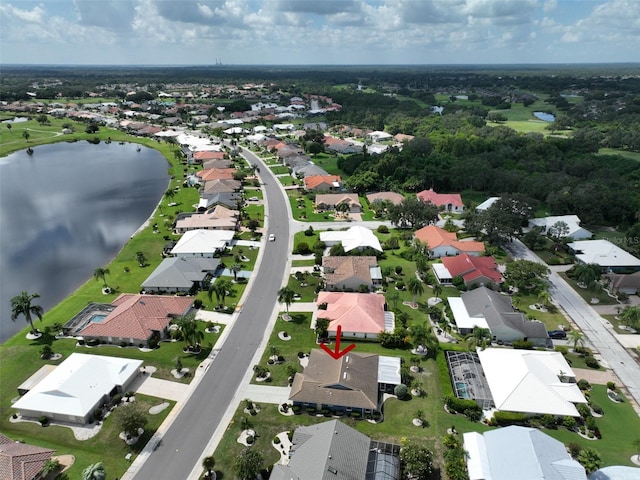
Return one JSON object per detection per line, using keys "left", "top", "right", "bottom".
{"left": 0, "top": 0, "right": 640, "bottom": 65}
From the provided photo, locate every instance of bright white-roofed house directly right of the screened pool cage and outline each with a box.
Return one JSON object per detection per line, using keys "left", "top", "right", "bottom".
{"left": 477, "top": 348, "right": 587, "bottom": 417}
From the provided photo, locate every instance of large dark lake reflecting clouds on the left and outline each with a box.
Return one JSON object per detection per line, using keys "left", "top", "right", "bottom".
{"left": 0, "top": 142, "right": 169, "bottom": 341}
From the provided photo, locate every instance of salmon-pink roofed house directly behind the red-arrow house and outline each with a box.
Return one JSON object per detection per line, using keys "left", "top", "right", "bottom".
{"left": 316, "top": 292, "right": 395, "bottom": 339}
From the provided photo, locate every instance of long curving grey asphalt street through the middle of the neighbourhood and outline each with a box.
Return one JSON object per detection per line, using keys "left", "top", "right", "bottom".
{"left": 134, "top": 150, "right": 291, "bottom": 480}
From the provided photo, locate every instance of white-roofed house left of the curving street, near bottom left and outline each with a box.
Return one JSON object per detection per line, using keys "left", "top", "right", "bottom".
{"left": 12, "top": 353, "right": 142, "bottom": 423}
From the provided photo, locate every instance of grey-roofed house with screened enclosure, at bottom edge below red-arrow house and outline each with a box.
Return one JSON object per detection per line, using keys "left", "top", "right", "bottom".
{"left": 269, "top": 420, "right": 400, "bottom": 480}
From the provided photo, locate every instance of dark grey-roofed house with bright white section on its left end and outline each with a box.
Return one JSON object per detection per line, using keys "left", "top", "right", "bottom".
{"left": 447, "top": 287, "right": 553, "bottom": 347}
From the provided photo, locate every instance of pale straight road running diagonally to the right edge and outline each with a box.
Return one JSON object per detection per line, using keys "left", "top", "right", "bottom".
{"left": 507, "top": 240, "right": 640, "bottom": 415}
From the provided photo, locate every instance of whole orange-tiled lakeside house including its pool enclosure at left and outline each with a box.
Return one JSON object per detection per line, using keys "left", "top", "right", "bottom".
{"left": 73, "top": 293, "right": 193, "bottom": 346}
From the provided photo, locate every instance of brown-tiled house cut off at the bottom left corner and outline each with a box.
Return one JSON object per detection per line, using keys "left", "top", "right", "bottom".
{"left": 0, "top": 433, "right": 55, "bottom": 480}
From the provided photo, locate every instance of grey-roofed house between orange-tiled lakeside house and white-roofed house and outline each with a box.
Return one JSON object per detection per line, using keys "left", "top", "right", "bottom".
{"left": 141, "top": 257, "right": 220, "bottom": 294}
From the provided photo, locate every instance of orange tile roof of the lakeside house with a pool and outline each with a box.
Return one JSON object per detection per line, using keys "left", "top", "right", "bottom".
{"left": 79, "top": 293, "right": 193, "bottom": 341}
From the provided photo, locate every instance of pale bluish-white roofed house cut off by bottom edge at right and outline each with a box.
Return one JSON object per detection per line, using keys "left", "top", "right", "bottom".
{"left": 463, "top": 425, "right": 587, "bottom": 480}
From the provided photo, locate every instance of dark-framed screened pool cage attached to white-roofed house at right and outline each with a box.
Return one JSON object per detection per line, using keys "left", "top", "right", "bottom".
{"left": 445, "top": 351, "right": 495, "bottom": 410}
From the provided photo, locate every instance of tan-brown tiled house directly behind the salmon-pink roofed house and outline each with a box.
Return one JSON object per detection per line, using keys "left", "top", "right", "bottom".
{"left": 322, "top": 256, "right": 382, "bottom": 292}
